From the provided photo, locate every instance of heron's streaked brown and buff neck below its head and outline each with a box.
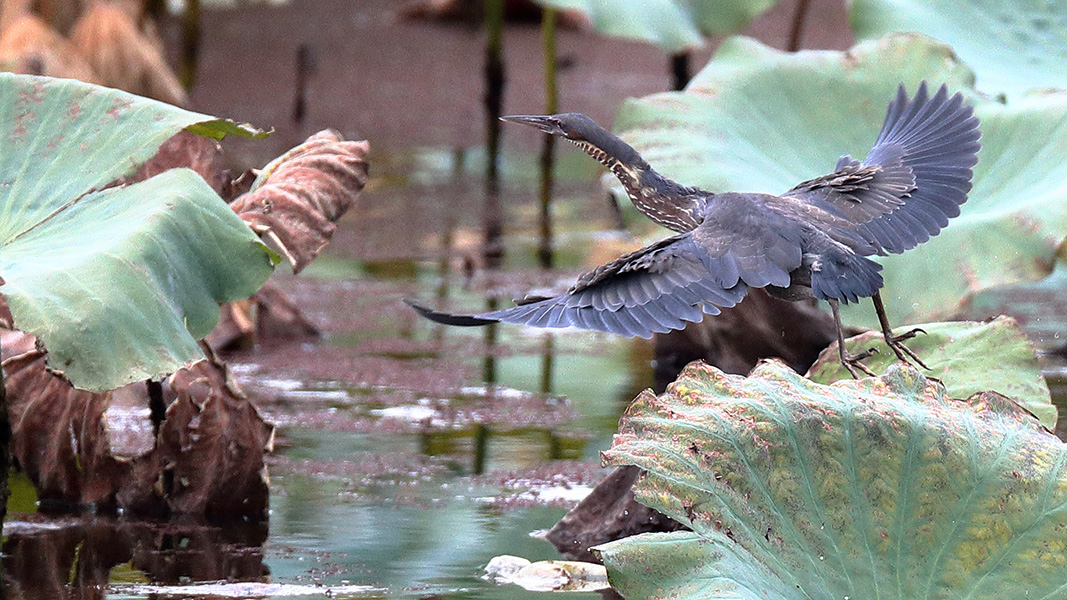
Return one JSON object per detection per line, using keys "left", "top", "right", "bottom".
{"left": 572, "top": 131, "right": 707, "bottom": 233}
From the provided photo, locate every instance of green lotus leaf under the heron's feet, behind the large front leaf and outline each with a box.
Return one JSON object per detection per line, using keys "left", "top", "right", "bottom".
{"left": 807, "top": 317, "right": 1056, "bottom": 429}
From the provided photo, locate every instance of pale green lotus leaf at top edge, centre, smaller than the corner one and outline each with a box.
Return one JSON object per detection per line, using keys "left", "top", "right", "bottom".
{"left": 535, "top": 0, "right": 778, "bottom": 53}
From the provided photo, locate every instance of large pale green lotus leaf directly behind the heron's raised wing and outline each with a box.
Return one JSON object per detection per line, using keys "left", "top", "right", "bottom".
{"left": 615, "top": 34, "right": 1067, "bottom": 327}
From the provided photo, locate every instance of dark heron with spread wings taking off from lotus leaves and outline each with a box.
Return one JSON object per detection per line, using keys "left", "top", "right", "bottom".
{"left": 412, "top": 82, "right": 981, "bottom": 376}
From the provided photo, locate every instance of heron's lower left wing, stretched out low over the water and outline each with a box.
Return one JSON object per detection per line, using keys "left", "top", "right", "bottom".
{"left": 408, "top": 233, "right": 747, "bottom": 337}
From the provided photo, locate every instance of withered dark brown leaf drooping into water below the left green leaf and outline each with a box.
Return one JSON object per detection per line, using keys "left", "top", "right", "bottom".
{"left": 3, "top": 333, "right": 274, "bottom": 520}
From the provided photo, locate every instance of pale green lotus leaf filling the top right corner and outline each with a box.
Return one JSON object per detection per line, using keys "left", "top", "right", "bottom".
{"left": 849, "top": 0, "right": 1067, "bottom": 98}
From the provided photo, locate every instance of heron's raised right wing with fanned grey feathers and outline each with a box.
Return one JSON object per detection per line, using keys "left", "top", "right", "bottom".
{"left": 783, "top": 81, "right": 981, "bottom": 253}
